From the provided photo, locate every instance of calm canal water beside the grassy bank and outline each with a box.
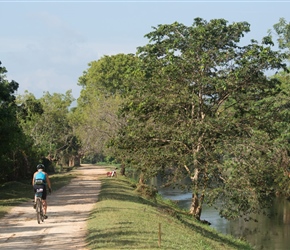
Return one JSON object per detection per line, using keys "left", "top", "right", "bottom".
{"left": 159, "top": 189, "right": 290, "bottom": 250}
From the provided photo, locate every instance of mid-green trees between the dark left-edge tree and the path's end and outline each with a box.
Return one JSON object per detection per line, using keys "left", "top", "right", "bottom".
{"left": 18, "top": 91, "right": 78, "bottom": 170}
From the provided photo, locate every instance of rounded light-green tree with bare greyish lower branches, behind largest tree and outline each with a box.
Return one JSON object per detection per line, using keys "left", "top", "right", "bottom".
{"left": 73, "top": 54, "right": 136, "bottom": 161}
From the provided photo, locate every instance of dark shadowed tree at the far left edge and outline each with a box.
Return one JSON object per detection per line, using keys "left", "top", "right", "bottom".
{"left": 0, "top": 62, "right": 33, "bottom": 182}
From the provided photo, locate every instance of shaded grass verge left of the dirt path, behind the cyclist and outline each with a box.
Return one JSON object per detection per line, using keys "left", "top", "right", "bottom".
{"left": 0, "top": 173, "right": 75, "bottom": 218}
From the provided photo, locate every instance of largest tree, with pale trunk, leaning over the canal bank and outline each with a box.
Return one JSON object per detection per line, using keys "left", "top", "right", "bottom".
{"left": 114, "top": 18, "right": 286, "bottom": 219}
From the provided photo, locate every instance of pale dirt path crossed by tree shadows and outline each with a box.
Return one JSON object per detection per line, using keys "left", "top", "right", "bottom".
{"left": 0, "top": 165, "right": 106, "bottom": 250}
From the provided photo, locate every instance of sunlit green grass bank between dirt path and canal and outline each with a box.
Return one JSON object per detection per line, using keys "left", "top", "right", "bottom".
{"left": 86, "top": 176, "right": 253, "bottom": 250}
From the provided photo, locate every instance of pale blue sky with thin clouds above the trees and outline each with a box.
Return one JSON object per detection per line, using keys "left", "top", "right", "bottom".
{"left": 0, "top": 0, "right": 290, "bottom": 98}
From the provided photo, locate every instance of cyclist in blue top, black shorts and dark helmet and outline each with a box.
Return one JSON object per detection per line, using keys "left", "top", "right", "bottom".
{"left": 32, "top": 164, "right": 51, "bottom": 219}
